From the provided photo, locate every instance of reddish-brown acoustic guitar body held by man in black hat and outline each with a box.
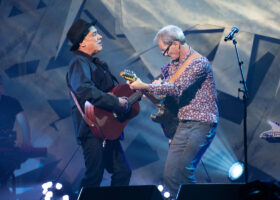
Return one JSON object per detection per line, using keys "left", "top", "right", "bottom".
{"left": 85, "top": 84, "right": 140, "bottom": 140}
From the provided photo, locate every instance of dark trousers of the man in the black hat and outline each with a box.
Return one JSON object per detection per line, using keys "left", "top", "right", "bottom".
{"left": 81, "top": 135, "right": 131, "bottom": 187}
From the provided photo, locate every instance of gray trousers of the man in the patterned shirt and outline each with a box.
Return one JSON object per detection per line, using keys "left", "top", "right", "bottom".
{"left": 164, "top": 121, "right": 217, "bottom": 198}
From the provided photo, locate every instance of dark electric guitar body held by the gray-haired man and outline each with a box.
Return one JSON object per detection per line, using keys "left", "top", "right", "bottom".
{"left": 150, "top": 96, "right": 179, "bottom": 139}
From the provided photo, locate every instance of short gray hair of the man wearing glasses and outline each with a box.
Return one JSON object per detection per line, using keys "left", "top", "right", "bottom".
{"left": 154, "top": 25, "right": 186, "bottom": 44}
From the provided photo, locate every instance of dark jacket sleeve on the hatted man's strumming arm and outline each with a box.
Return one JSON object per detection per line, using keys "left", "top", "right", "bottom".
{"left": 68, "top": 59, "right": 119, "bottom": 111}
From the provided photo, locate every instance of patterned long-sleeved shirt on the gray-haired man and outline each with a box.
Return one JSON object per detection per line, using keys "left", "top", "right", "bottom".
{"left": 148, "top": 49, "right": 219, "bottom": 123}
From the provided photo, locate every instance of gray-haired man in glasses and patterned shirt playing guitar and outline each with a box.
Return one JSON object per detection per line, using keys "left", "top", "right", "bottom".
{"left": 130, "top": 25, "right": 219, "bottom": 198}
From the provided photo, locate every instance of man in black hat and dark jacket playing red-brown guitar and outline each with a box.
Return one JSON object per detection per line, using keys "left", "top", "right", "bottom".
{"left": 67, "top": 19, "right": 131, "bottom": 187}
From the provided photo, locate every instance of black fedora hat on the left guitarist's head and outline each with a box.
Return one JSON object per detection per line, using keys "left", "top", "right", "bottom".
{"left": 67, "top": 19, "right": 96, "bottom": 51}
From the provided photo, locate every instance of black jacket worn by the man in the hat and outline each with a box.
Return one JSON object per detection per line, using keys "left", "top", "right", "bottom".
{"left": 66, "top": 51, "right": 119, "bottom": 139}
